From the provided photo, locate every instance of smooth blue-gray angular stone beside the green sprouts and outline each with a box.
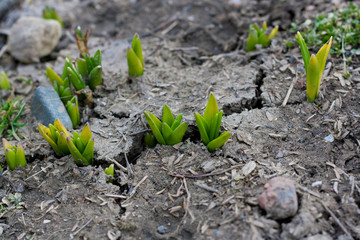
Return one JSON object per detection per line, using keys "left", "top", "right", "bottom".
{"left": 31, "top": 86, "right": 72, "bottom": 129}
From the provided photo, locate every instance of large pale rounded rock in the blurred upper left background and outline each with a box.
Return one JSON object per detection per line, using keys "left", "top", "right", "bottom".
{"left": 7, "top": 17, "right": 61, "bottom": 63}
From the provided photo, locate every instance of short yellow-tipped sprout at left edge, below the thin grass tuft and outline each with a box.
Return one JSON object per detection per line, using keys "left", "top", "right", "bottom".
{"left": 2, "top": 138, "right": 26, "bottom": 170}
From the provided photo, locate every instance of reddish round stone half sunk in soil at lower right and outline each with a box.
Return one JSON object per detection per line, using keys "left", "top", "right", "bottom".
{"left": 259, "top": 177, "right": 298, "bottom": 219}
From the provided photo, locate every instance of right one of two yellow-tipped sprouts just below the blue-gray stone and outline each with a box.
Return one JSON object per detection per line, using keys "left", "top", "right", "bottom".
{"left": 66, "top": 124, "right": 94, "bottom": 165}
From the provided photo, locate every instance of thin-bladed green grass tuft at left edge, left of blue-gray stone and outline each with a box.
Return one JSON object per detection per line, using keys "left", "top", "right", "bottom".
{"left": 0, "top": 94, "right": 26, "bottom": 141}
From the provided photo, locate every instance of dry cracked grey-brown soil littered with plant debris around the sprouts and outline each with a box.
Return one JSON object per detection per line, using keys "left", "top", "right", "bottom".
{"left": 0, "top": 0, "right": 360, "bottom": 239}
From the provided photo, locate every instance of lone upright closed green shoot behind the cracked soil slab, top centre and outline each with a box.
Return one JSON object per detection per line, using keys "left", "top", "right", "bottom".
{"left": 127, "top": 34, "right": 144, "bottom": 77}
